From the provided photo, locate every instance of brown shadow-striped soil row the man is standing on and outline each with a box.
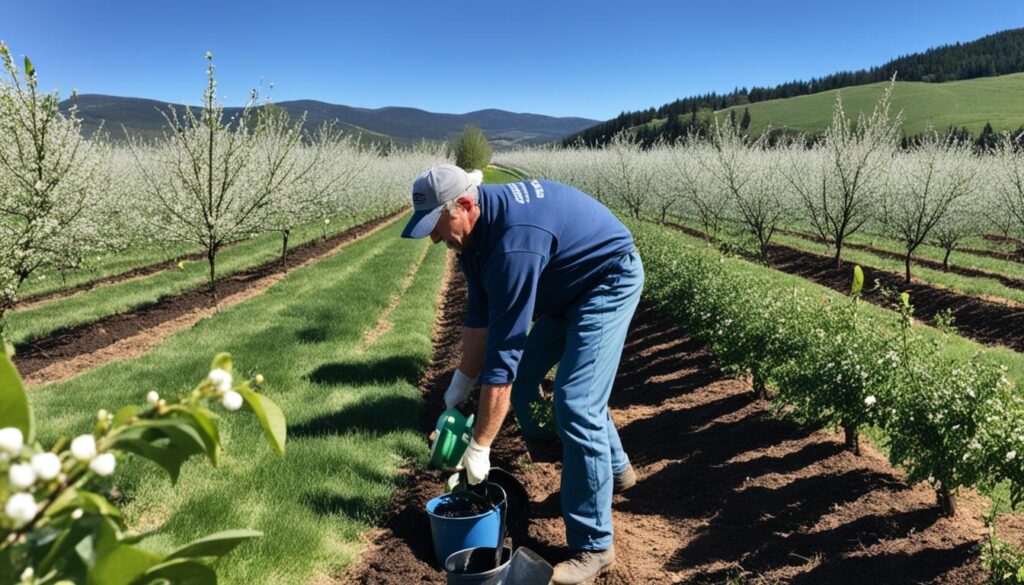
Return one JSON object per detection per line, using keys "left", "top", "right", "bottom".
{"left": 342, "top": 261, "right": 1020, "bottom": 585}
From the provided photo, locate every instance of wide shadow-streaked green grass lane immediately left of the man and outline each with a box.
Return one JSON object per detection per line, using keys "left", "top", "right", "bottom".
{"left": 30, "top": 222, "right": 445, "bottom": 584}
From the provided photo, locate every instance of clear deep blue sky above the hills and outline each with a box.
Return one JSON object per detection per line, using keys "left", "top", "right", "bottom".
{"left": 0, "top": 0, "right": 1024, "bottom": 119}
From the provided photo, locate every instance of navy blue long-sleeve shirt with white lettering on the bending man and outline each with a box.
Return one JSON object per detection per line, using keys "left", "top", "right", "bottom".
{"left": 459, "top": 180, "right": 635, "bottom": 384}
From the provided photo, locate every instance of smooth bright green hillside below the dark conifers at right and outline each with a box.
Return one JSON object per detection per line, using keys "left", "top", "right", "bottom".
{"left": 716, "top": 73, "right": 1024, "bottom": 136}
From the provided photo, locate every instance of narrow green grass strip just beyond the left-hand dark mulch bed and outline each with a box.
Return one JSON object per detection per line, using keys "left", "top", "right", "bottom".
{"left": 4, "top": 211, "right": 391, "bottom": 345}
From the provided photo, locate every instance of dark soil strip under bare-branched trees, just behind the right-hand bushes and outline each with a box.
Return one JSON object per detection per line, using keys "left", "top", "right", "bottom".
{"left": 671, "top": 224, "right": 1024, "bottom": 351}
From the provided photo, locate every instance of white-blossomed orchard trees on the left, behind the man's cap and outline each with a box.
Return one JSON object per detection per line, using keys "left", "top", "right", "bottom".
{"left": 0, "top": 44, "right": 446, "bottom": 325}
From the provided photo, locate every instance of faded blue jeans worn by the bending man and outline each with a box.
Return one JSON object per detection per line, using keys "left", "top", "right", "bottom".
{"left": 511, "top": 252, "right": 643, "bottom": 550}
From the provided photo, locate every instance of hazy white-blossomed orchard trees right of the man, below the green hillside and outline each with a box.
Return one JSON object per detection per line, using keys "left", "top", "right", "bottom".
{"left": 501, "top": 86, "right": 1024, "bottom": 282}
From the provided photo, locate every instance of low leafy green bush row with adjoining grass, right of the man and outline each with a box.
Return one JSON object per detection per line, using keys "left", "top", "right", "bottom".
{"left": 631, "top": 222, "right": 1024, "bottom": 516}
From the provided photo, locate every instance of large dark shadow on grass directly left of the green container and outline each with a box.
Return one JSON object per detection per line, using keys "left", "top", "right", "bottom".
{"left": 288, "top": 394, "right": 422, "bottom": 437}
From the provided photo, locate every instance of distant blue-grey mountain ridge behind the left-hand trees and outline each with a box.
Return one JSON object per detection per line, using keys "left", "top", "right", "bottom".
{"left": 61, "top": 93, "right": 599, "bottom": 148}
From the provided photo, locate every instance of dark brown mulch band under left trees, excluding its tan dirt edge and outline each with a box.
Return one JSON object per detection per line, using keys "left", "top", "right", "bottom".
{"left": 14, "top": 209, "right": 404, "bottom": 376}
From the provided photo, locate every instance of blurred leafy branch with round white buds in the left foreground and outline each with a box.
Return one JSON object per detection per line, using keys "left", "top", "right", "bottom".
{"left": 0, "top": 353, "right": 287, "bottom": 585}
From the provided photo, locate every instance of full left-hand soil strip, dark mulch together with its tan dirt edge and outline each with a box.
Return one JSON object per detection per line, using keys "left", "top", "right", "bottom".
{"left": 14, "top": 211, "right": 404, "bottom": 385}
